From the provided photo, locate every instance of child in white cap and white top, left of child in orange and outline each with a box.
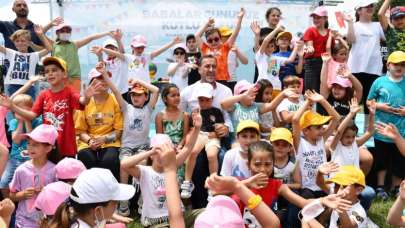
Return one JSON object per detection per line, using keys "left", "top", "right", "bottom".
{"left": 167, "top": 44, "right": 197, "bottom": 91}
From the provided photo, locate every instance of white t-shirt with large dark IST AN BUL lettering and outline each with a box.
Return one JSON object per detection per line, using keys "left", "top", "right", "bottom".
{"left": 4, "top": 48, "right": 39, "bottom": 85}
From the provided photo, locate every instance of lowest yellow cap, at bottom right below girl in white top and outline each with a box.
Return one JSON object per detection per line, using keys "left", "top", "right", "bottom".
{"left": 326, "top": 165, "right": 366, "bottom": 187}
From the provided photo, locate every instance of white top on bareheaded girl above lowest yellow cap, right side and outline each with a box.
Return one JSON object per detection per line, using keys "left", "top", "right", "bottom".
{"left": 331, "top": 140, "right": 360, "bottom": 168}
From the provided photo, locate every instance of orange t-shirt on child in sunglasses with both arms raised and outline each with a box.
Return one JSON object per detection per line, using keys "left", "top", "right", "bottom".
{"left": 201, "top": 43, "right": 231, "bottom": 81}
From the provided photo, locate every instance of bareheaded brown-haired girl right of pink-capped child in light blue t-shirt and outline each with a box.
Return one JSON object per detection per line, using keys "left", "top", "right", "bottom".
{"left": 255, "top": 79, "right": 279, "bottom": 139}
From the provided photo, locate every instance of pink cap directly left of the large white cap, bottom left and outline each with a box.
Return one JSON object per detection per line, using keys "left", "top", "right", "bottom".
{"left": 34, "top": 181, "right": 72, "bottom": 215}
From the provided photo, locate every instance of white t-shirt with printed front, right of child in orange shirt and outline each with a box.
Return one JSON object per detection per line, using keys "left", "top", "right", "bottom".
{"left": 255, "top": 51, "right": 285, "bottom": 90}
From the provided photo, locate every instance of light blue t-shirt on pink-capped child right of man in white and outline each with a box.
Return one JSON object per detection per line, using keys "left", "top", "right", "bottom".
{"left": 231, "top": 102, "right": 262, "bottom": 129}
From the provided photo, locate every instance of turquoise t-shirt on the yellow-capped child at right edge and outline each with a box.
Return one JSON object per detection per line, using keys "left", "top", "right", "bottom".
{"left": 367, "top": 76, "right": 405, "bottom": 143}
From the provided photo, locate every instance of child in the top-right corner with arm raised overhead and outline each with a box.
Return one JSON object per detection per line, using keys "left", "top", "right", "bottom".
{"left": 378, "top": 0, "right": 405, "bottom": 54}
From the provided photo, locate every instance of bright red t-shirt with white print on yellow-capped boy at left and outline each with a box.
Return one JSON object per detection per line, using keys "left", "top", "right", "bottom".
{"left": 32, "top": 87, "right": 84, "bottom": 156}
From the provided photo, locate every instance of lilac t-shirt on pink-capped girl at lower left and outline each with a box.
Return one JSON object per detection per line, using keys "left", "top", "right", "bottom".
{"left": 10, "top": 160, "right": 57, "bottom": 228}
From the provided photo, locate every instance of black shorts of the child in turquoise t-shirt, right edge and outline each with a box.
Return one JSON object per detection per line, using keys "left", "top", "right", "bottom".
{"left": 374, "top": 139, "right": 405, "bottom": 178}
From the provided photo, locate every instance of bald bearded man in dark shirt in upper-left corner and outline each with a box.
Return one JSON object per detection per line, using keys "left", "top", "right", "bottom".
{"left": 0, "top": 0, "right": 42, "bottom": 52}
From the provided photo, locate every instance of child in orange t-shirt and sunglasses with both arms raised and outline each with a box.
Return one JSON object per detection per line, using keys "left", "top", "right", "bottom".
{"left": 195, "top": 8, "right": 245, "bottom": 84}
